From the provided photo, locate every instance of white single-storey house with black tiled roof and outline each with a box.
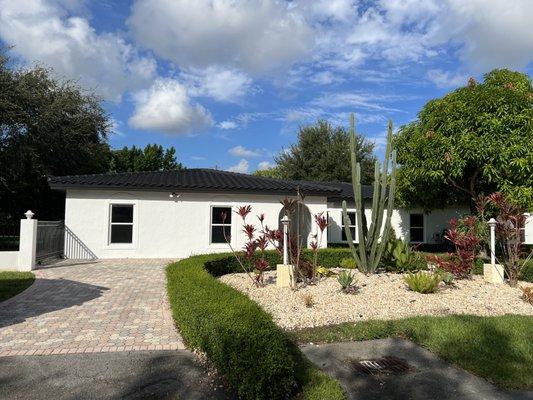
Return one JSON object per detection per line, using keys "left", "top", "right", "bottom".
{"left": 49, "top": 169, "right": 474, "bottom": 259}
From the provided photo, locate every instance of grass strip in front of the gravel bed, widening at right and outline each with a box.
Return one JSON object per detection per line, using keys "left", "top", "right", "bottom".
{"left": 292, "top": 315, "right": 533, "bottom": 389}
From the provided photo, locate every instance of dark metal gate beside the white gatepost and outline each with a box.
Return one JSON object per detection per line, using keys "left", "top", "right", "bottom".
{"left": 35, "top": 221, "right": 65, "bottom": 262}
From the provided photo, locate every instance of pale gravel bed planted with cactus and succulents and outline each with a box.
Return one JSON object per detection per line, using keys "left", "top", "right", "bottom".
{"left": 219, "top": 269, "right": 533, "bottom": 329}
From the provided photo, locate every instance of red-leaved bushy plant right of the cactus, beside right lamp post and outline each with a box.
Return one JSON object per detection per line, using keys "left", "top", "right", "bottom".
{"left": 428, "top": 216, "right": 481, "bottom": 278}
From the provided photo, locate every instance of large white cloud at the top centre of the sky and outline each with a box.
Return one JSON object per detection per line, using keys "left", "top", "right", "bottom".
{"left": 128, "top": 0, "right": 313, "bottom": 73}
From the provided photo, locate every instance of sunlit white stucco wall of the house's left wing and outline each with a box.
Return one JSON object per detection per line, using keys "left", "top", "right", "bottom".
{"left": 65, "top": 189, "right": 327, "bottom": 258}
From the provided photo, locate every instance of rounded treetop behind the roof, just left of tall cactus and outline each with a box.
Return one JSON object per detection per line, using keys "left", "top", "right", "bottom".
{"left": 274, "top": 120, "right": 375, "bottom": 184}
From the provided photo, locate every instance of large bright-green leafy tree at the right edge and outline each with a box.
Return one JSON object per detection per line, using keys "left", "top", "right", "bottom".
{"left": 395, "top": 69, "right": 533, "bottom": 210}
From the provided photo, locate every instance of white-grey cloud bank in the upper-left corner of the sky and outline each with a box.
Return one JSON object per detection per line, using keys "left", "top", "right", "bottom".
{"left": 0, "top": 0, "right": 156, "bottom": 101}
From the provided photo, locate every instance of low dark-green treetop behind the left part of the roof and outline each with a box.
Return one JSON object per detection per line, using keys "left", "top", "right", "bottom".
{"left": 109, "top": 144, "right": 183, "bottom": 172}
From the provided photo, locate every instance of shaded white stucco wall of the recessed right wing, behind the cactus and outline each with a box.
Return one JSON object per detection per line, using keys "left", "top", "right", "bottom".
{"left": 328, "top": 203, "right": 470, "bottom": 244}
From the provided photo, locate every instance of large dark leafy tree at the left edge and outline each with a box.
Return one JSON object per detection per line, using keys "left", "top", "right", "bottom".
{"left": 0, "top": 54, "right": 110, "bottom": 220}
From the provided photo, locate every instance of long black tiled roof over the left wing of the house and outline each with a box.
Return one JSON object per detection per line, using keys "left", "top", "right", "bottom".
{"left": 48, "top": 168, "right": 343, "bottom": 198}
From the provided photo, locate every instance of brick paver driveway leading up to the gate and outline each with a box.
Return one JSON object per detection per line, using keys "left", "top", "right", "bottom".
{"left": 0, "top": 259, "right": 184, "bottom": 356}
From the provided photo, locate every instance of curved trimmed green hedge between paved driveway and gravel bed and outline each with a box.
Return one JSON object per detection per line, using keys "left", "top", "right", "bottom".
{"left": 167, "top": 252, "right": 344, "bottom": 399}
